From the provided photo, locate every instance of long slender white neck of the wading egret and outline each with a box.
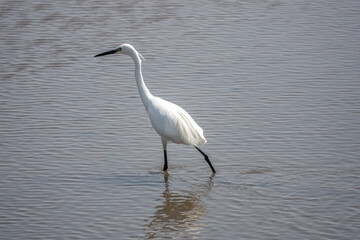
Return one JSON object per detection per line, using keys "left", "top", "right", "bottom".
{"left": 131, "top": 52, "right": 152, "bottom": 111}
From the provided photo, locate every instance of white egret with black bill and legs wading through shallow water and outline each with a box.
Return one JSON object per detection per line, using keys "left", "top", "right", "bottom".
{"left": 95, "top": 43, "right": 215, "bottom": 173}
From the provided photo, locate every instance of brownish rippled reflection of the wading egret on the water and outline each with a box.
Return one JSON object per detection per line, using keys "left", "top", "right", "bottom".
{"left": 145, "top": 172, "right": 213, "bottom": 239}
